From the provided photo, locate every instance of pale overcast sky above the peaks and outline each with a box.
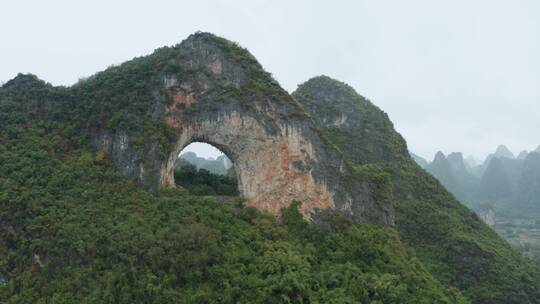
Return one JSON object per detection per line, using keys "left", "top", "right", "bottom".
{"left": 0, "top": 0, "right": 540, "bottom": 159}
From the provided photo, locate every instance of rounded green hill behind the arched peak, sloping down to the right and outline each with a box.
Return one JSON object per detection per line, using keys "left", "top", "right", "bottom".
{"left": 293, "top": 76, "right": 540, "bottom": 303}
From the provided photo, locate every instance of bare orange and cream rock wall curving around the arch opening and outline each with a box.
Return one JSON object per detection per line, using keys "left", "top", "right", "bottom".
{"left": 160, "top": 105, "right": 335, "bottom": 214}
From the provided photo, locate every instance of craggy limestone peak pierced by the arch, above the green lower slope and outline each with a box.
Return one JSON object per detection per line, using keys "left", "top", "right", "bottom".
{"left": 0, "top": 33, "right": 394, "bottom": 226}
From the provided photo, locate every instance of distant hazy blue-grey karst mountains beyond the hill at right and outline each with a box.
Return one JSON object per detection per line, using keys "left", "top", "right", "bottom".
{"left": 411, "top": 145, "right": 540, "bottom": 218}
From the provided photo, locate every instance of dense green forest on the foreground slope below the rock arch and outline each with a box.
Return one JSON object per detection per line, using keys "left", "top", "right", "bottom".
{"left": 0, "top": 100, "right": 467, "bottom": 304}
